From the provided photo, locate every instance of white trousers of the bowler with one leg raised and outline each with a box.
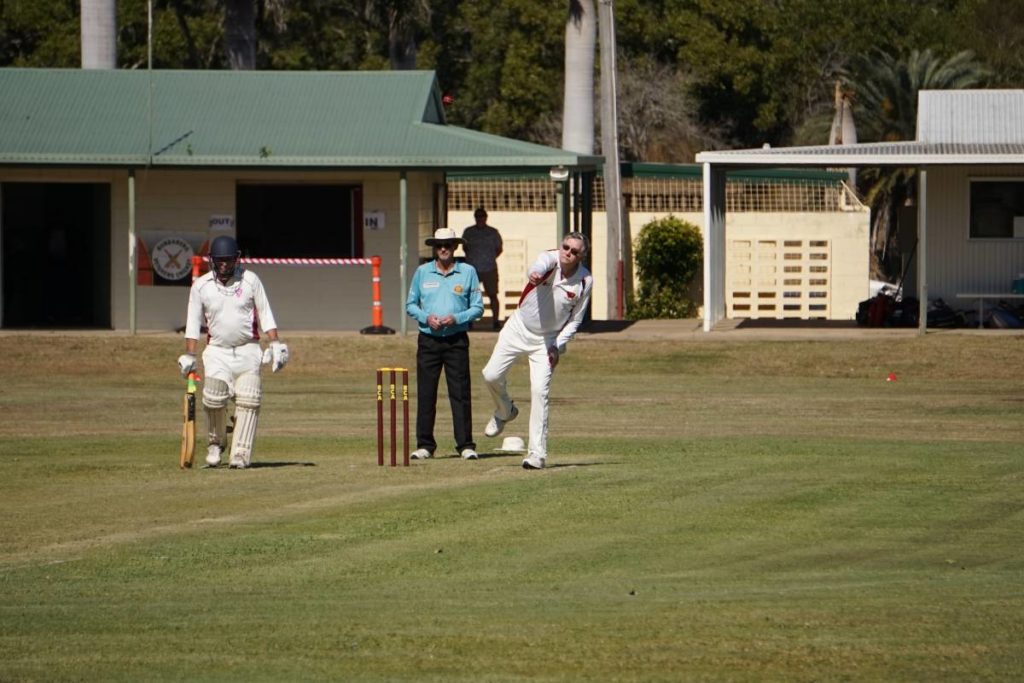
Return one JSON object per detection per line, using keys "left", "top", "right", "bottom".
{"left": 483, "top": 311, "right": 552, "bottom": 458}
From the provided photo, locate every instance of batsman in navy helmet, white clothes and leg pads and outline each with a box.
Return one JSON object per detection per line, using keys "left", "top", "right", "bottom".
{"left": 178, "top": 236, "right": 289, "bottom": 469}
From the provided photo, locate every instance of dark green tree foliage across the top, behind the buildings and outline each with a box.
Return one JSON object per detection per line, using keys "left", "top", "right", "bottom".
{"left": 0, "top": 0, "right": 1024, "bottom": 153}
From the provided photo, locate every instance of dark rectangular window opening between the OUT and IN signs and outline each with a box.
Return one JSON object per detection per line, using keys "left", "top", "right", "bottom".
{"left": 236, "top": 184, "right": 362, "bottom": 258}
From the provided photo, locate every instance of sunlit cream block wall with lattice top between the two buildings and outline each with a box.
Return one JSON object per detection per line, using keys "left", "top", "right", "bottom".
{"left": 447, "top": 164, "right": 869, "bottom": 321}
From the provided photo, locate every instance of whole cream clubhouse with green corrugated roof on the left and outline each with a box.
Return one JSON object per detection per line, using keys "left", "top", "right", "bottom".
{"left": 0, "top": 69, "right": 601, "bottom": 332}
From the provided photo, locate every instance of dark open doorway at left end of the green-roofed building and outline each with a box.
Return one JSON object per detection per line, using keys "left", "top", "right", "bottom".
{"left": 0, "top": 182, "right": 111, "bottom": 329}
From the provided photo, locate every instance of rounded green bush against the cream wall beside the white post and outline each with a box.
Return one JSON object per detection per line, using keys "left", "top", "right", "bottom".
{"left": 629, "top": 215, "right": 703, "bottom": 319}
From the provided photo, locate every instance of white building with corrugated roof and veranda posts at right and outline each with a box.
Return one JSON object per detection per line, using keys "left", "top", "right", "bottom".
{"left": 697, "top": 90, "right": 1024, "bottom": 332}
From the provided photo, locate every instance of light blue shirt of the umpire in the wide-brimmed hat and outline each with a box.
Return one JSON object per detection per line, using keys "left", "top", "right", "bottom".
{"left": 406, "top": 259, "right": 483, "bottom": 337}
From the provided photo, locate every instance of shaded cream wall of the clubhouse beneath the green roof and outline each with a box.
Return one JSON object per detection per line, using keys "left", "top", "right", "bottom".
{"left": 0, "top": 169, "right": 443, "bottom": 334}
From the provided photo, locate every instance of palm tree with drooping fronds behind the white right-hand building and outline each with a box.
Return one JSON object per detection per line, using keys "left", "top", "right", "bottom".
{"left": 848, "top": 49, "right": 990, "bottom": 280}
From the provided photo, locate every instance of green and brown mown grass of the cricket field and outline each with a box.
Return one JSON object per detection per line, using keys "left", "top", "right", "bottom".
{"left": 0, "top": 334, "right": 1024, "bottom": 681}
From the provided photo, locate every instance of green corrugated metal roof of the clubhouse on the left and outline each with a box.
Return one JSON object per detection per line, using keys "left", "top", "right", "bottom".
{"left": 0, "top": 69, "right": 601, "bottom": 169}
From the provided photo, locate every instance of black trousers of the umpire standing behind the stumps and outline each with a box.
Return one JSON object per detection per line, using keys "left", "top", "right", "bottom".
{"left": 416, "top": 332, "right": 476, "bottom": 454}
